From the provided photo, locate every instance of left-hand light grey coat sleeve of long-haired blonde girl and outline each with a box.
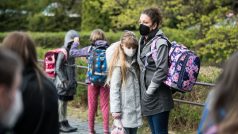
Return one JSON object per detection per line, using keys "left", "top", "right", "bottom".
{"left": 110, "top": 67, "right": 122, "bottom": 113}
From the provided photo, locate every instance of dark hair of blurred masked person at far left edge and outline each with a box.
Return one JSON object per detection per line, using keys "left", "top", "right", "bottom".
{"left": 0, "top": 47, "right": 22, "bottom": 88}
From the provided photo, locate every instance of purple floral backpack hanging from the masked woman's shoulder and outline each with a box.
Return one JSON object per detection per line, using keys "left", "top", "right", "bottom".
{"left": 148, "top": 37, "right": 200, "bottom": 92}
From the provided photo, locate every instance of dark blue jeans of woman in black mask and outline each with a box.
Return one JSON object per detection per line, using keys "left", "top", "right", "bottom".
{"left": 147, "top": 111, "right": 170, "bottom": 134}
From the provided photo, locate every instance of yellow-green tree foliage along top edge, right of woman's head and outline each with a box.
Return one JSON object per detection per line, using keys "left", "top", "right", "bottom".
{"left": 161, "top": 0, "right": 233, "bottom": 37}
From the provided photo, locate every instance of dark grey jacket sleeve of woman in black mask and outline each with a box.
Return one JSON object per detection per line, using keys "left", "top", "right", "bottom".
{"left": 146, "top": 42, "right": 169, "bottom": 94}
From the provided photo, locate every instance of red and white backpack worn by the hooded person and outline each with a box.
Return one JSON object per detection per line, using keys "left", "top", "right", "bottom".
{"left": 43, "top": 48, "right": 67, "bottom": 79}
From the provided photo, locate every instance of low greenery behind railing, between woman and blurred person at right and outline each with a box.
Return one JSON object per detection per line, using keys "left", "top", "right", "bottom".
{"left": 169, "top": 66, "right": 221, "bottom": 133}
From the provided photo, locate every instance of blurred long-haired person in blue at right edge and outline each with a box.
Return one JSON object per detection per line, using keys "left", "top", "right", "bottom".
{"left": 198, "top": 52, "right": 238, "bottom": 134}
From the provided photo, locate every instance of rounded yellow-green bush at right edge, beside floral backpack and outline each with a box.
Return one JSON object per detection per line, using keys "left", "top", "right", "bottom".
{"left": 195, "top": 26, "right": 238, "bottom": 64}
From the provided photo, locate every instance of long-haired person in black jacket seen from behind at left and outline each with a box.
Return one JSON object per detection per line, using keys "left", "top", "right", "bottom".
{"left": 2, "top": 32, "right": 59, "bottom": 134}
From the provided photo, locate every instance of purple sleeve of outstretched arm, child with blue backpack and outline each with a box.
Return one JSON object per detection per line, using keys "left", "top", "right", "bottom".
{"left": 69, "top": 42, "right": 90, "bottom": 57}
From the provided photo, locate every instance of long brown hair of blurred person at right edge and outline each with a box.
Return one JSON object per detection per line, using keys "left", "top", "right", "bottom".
{"left": 212, "top": 52, "right": 238, "bottom": 133}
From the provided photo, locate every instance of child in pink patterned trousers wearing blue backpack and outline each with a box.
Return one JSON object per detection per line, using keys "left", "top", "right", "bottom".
{"left": 70, "top": 29, "right": 109, "bottom": 134}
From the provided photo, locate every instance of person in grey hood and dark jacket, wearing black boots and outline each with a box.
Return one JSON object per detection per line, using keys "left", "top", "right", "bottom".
{"left": 54, "top": 30, "right": 79, "bottom": 132}
